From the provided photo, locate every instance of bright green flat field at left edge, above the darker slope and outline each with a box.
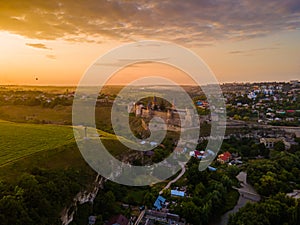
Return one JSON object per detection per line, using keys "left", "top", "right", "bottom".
{"left": 0, "top": 120, "right": 74, "bottom": 166}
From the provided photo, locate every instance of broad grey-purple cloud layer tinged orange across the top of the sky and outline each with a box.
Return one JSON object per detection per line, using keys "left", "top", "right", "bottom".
{"left": 0, "top": 0, "right": 300, "bottom": 45}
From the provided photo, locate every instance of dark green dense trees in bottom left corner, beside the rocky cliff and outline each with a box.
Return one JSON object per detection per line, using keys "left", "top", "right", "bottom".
{"left": 0, "top": 169, "right": 90, "bottom": 225}
